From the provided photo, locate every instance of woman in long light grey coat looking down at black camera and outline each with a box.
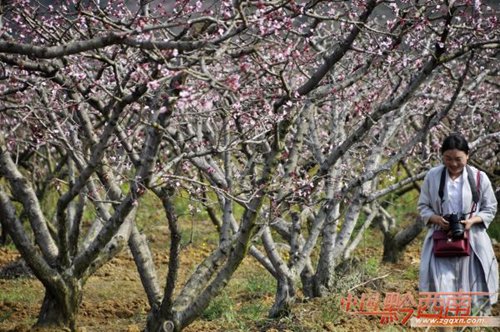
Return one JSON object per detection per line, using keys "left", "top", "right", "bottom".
{"left": 418, "top": 134, "right": 498, "bottom": 315}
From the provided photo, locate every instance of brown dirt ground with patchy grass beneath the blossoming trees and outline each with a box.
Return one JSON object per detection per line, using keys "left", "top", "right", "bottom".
{"left": 0, "top": 231, "right": 500, "bottom": 332}
